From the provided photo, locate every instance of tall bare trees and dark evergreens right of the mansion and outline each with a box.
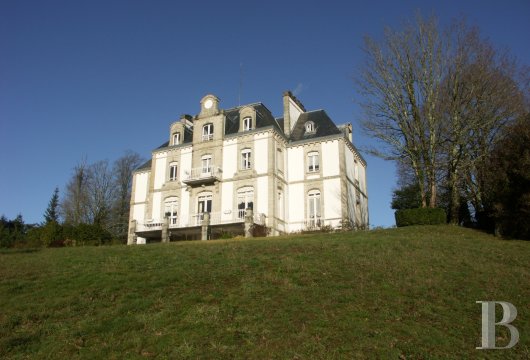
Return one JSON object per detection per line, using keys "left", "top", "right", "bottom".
{"left": 356, "top": 15, "right": 530, "bottom": 238}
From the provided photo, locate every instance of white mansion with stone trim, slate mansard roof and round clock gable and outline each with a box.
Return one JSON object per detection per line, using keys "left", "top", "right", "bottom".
{"left": 128, "top": 92, "right": 368, "bottom": 244}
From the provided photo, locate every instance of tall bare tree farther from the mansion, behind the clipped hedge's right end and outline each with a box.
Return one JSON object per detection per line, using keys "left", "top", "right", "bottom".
{"left": 440, "top": 23, "right": 524, "bottom": 223}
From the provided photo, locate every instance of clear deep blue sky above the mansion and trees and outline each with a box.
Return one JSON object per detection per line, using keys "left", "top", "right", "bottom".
{"left": 0, "top": 0, "right": 530, "bottom": 226}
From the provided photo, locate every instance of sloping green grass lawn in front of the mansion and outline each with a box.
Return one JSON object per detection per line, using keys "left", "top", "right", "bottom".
{"left": 0, "top": 226, "right": 530, "bottom": 359}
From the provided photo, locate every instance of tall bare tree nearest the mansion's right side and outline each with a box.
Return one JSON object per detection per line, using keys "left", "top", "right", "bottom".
{"left": 357, "top": 16, "right": 446, "bottom": 207}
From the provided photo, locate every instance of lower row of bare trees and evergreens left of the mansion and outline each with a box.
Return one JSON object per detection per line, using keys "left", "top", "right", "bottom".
{"left": 0, "top": 151, "right": 143, "bottom": 247}
